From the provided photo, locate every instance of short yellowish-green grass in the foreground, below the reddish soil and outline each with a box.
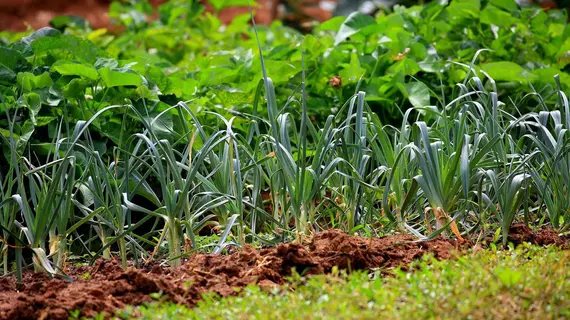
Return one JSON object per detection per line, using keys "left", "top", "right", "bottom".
{"left": 113, "top": 245, "right": 570, "bottom": 320}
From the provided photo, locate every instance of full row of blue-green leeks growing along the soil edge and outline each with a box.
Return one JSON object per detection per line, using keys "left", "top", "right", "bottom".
{"left": 0, "top": 55, "right": 570, "bottom": 275}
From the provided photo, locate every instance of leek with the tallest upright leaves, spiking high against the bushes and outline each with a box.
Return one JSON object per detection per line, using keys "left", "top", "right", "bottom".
{"left": 250, "top": 21, "right": 342, "bottom": 242}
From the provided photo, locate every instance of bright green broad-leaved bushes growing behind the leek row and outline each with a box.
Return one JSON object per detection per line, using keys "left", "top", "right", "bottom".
{"left": 0, "top": 0, "right": 570, "bottom": 157}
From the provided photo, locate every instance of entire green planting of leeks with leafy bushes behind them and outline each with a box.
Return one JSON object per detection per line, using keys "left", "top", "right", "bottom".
{"left": 0, "top": 0, "right": 570, "bottom": 278}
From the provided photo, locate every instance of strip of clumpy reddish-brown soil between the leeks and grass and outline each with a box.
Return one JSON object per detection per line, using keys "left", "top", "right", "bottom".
{"left": 0, "top": 230, "right": 559, "bottom": 319}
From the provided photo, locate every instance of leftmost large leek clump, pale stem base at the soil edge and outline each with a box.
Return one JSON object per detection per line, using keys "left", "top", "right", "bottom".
{"left": 2, "top": 92, "right": 123, "bottom": 275}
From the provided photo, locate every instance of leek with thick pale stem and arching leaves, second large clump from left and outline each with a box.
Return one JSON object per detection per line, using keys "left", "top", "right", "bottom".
{"left": 123, "top": 103, "right": 230, "bottom": 267}
